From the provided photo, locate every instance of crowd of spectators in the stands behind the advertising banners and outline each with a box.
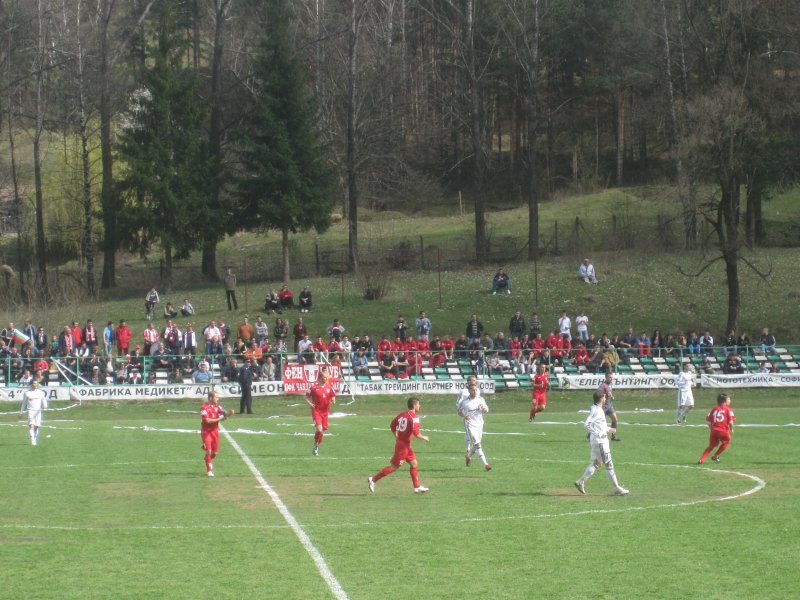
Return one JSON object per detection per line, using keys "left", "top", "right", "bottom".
{"left": 0, "top": 278, "right": 777, "bottom": 385}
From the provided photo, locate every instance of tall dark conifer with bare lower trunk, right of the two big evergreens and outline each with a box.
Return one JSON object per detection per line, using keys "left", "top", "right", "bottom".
{"left": 231, "top": 1, "right": 335, "bottom": 280}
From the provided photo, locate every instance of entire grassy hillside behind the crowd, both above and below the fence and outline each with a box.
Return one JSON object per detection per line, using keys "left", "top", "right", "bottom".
{"left": 0, "top": 183, "right": 800, "bottom": 343}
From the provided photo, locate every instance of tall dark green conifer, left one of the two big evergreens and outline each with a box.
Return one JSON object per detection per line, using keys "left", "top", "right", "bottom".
{"left": 114, "top": 3, "right": 214, "bottom": 279}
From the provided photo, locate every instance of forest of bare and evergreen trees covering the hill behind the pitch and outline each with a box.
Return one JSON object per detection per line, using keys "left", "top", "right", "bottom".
{"left": 0, "top": 0, "right": 800, "bottom": 336}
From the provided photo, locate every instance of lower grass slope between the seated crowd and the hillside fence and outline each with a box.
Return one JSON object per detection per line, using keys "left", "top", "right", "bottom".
{"left": 2, "top": 249, "right": 800, "bottom": 343}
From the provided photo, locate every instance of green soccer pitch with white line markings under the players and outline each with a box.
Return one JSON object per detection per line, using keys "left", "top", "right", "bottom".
{"left": 0, "top": 390, "right": 800, "bottom": 599}
